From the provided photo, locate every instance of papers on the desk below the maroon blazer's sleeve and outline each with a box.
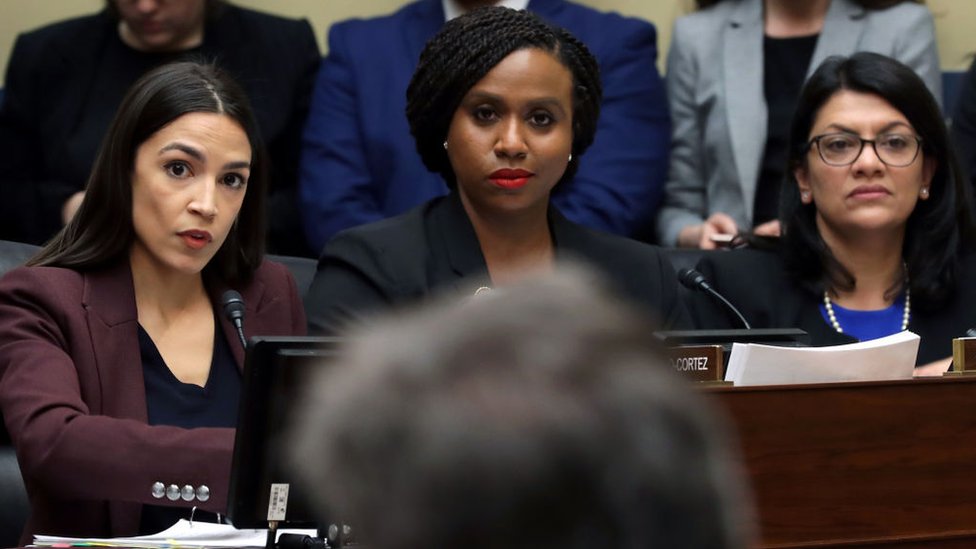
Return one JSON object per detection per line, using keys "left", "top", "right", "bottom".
{"left": 34, "top": 520, "right": 315, "bottom": 549}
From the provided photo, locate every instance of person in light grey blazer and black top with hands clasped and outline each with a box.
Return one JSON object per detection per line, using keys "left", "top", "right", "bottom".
{"left": 657, "top": 0, "right": 941, "bottom": 249}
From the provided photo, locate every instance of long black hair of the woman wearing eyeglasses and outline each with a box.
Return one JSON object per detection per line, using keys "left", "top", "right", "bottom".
{"left": 780, "top": 52, "right": 974, "bottom": 308}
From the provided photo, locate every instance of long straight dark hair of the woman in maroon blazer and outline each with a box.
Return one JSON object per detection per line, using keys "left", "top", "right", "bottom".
{"left": 28, "top": 62, "right": 267, "bottom": 286}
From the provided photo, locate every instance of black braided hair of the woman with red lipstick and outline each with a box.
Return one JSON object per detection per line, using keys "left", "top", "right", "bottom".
{"left": 407, "top": 6, "right": 603, "bottom": 189}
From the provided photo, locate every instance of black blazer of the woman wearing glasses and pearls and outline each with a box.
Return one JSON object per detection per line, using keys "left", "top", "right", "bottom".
{"left": 689, "top": 250, "right": 976, "bottom": 365}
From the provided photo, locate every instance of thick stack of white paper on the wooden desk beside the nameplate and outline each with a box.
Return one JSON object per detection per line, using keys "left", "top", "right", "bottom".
{"left": 725, "top": 331, "right": 919, "bottom": 385}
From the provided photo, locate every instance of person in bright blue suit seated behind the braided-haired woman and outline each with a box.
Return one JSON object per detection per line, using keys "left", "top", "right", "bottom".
{"left": 300, "top": 0, "right": 670, "bottom": 250}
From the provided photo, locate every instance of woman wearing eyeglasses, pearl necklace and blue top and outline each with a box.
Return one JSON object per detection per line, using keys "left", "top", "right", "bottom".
{"left": 692, "top": 53, "right": 976, "bottom": 369}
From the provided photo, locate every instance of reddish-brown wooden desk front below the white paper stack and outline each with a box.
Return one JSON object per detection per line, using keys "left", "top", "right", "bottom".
{"left": 705, "top": 377, "right": 976, "bottom": 547}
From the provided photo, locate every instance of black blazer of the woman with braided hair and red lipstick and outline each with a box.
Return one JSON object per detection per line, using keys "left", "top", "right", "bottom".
{"left": 305, "top": 193, "right": 687, "bottom": 333}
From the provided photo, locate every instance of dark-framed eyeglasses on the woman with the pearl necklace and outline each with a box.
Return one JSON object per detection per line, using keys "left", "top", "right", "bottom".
{"left": 807, "top": 133, "right": 922, "bottom": 168}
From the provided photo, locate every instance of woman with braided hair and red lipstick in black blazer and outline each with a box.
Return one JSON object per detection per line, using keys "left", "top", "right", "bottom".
{"left": 306, "top": 6, "right": 685, "bottom": 332}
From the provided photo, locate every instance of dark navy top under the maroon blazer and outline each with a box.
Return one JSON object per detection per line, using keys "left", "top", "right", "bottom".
{"left": 139, "top": 315, "right": 241, "bottom": 534}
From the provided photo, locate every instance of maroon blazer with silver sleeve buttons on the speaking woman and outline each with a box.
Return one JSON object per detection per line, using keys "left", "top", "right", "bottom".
{"left": 0, "top": 261, "right": 305, "bottom": 545}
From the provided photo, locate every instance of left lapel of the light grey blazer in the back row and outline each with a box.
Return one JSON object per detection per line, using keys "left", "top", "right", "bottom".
{"left": 722, "top": 0, "right": 767, "bottom": 218}
